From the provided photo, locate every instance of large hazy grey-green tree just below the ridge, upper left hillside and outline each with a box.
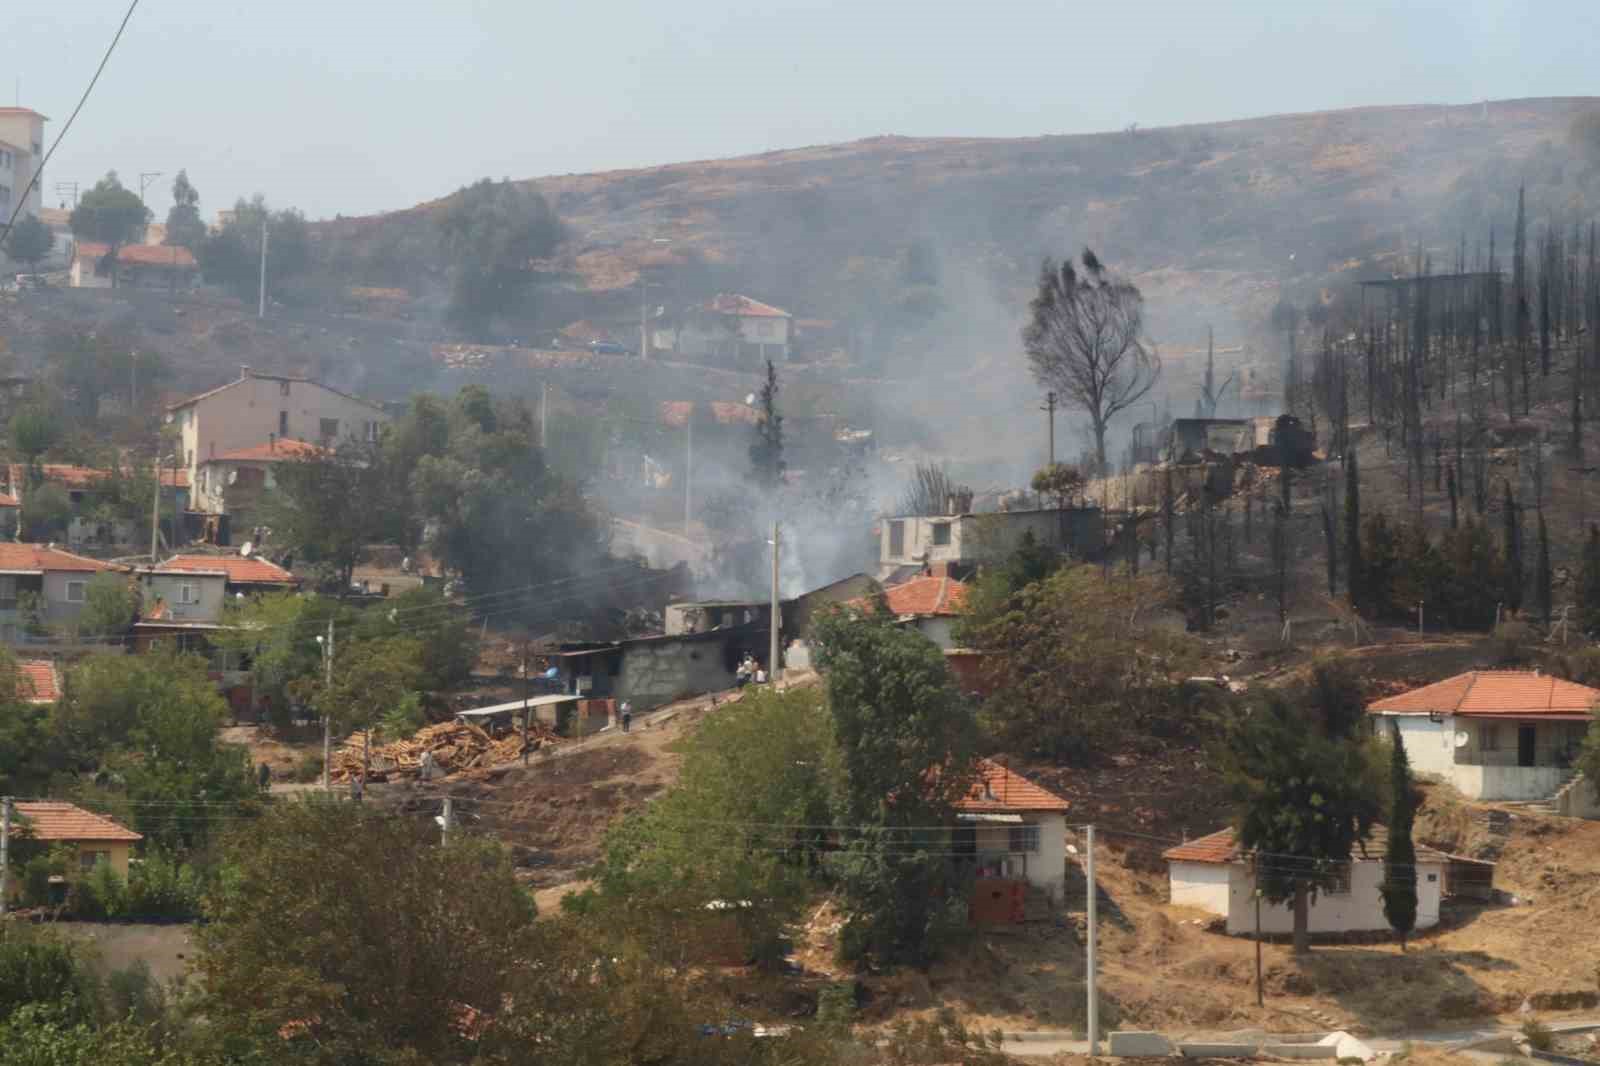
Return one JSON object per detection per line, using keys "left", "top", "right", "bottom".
{"left": 438, "top": 178, "right": 563, "bottom": 333}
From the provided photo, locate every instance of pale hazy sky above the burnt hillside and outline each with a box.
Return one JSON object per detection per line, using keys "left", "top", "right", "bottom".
{"left": 0, "top": 0, "right": 1600, "bottom": 218}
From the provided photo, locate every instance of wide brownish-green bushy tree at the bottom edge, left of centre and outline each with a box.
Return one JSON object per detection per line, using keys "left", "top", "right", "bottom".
{"left": 195, "top": 802, "right": 537, "bottom": 1066}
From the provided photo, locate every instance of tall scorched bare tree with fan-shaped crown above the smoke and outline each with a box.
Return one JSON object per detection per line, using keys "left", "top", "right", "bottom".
{"left": 1022, "top": 248, "right": 1162, "bottom": 474}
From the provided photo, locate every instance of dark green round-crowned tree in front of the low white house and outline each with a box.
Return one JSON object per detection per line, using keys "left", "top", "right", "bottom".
{"left": 1218, "top": 667, "right": 1379, "bottom": 954}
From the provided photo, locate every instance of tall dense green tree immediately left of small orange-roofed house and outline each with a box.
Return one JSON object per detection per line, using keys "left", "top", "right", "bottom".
{"left": 813, "top": 608, "right": 978, "bottom": 962}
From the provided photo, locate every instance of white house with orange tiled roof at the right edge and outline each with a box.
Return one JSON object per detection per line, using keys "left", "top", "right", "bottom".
{"left": 1366, "top": 671, "right": 1600, "bottom": 800}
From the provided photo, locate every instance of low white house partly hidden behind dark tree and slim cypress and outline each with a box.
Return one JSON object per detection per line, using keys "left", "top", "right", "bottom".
{"left": 1162, "top": 826, "right": 1450, "bottom": 936}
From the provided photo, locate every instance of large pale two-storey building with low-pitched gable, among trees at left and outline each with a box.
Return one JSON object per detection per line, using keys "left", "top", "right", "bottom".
{"left": 166, "top": 367, "right": 389, "bottom": 501}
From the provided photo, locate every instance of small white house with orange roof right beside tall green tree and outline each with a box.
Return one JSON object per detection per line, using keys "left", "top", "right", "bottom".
{"left": 950, "top": 759, "right": 1069, "bottom": 901}
